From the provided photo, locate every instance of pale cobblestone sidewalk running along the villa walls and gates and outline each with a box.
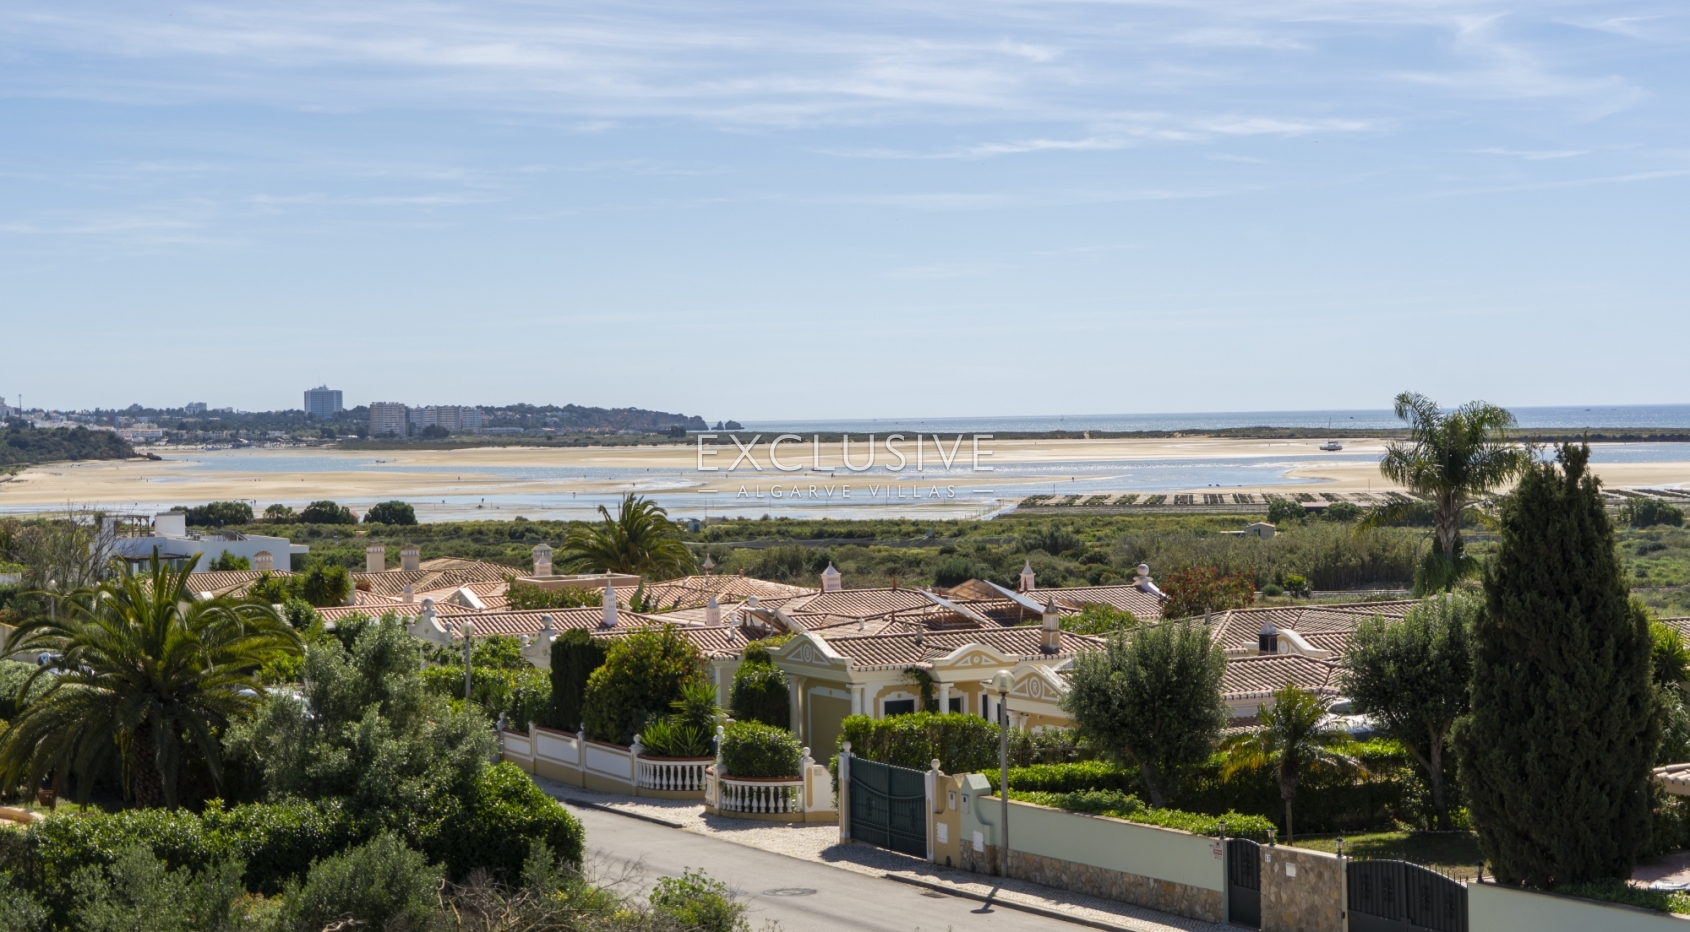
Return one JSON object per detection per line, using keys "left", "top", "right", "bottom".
{"left": 534, "top": 776, "right": 1232, "bottom": 932}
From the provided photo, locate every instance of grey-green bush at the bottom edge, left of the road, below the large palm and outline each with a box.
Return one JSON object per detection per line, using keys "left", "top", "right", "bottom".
{"left": 277, "top": 834, "right": 441, "bottom": 932}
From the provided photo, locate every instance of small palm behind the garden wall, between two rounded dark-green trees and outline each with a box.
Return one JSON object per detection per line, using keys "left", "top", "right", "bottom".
{"left": 1220, "top": 683, "right": 1367, "bottom": 844}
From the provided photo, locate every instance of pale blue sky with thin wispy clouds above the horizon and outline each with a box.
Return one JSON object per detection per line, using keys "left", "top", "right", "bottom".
{"left": 0, "top": 0, "right": 1690, "bottom": 419}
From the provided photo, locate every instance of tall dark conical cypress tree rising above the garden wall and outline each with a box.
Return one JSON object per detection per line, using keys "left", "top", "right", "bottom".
{"left": 1455, "top": 443, "right": 1661, "bottom": 888}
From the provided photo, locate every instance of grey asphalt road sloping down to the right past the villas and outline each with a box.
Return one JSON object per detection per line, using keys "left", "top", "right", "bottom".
{"left": 570, "top": 805, "right": 1085, "bottom": 932}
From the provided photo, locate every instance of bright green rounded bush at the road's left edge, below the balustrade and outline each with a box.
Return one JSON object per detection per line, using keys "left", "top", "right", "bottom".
{"left": 419, "top": 763, "right": 586, "bottom": 883}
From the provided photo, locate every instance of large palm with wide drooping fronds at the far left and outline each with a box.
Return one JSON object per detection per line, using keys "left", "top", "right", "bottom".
{"left": 0, "top": 553, "right": 301, "bottom": 807}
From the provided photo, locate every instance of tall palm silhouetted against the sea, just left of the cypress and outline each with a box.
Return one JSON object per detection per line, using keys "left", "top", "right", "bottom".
{"left": 1369, "top": 392, "right": 1531, "bottom": 590}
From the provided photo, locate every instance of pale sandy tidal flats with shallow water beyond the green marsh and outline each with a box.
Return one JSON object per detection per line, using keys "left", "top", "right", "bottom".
{"left": 0, "top": 436, "right": 1690, "bottom": 519}
